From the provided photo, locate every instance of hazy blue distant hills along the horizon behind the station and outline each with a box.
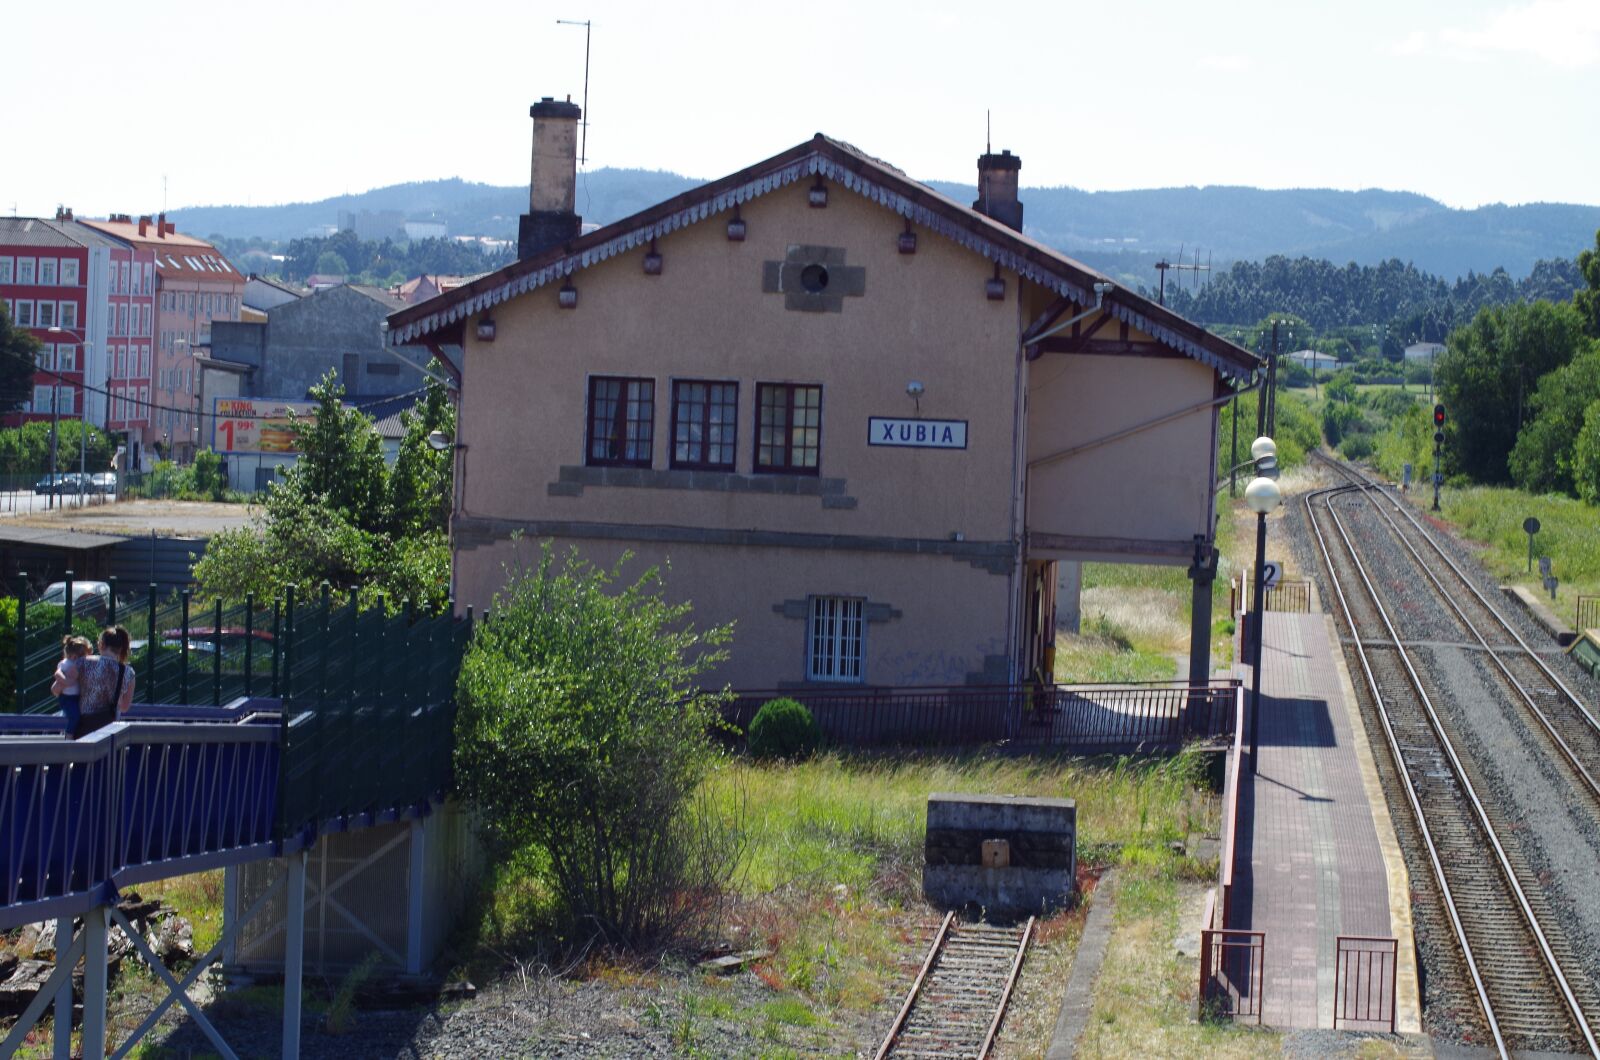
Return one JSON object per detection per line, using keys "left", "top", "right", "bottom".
{"left": 171, "top": 170, "right": 1600, "bottom": 285}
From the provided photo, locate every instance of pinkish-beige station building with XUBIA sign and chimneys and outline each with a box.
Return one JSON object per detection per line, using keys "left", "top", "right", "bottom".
{"left": 387, "top": 99, "right": 1258, "bottom": 690}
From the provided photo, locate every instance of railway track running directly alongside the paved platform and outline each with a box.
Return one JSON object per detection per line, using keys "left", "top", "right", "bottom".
{"left": 1306, "top": 461, "right": 1600, "bottom": 1057}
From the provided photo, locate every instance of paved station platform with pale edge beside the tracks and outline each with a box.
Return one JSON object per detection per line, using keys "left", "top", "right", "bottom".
{"left": 1229, "top": 612, "right": 1421, "bottom": 1031}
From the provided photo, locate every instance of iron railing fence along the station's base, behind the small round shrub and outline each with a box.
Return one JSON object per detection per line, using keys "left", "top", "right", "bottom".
{"left": 723, "top": 681, "right": 1238, "bottom": 751}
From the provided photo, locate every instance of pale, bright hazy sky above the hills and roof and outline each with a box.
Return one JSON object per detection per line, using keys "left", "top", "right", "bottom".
{"left": 0, "top": 0, "right": 1600, "bottom": 215}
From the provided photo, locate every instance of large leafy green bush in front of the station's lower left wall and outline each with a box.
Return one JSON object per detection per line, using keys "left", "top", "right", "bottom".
{"left": 456, "top": 543, "right": 742, "bottom": 948}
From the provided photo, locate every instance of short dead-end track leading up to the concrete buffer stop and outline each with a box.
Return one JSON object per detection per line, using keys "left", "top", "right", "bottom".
{"left": 874, "top": 913, "right": 1034, "bottom": 1060}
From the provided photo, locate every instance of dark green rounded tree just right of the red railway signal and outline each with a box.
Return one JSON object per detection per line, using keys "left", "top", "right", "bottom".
{"left": 1434, "top": 301, "right": 1586, "bottom": 482}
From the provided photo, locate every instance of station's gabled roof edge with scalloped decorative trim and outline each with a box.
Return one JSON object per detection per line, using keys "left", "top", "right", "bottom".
{"left": 389, "top": 133, "right": 1259, "bottom": 376}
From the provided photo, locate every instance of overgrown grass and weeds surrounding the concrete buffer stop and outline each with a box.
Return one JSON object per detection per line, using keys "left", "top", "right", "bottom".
{"left": 464, "top": 754, "right": 1218, "bottom": 1057}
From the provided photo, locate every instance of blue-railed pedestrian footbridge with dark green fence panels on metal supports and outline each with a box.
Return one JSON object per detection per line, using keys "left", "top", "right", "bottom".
{"left": 0, "top": 586, "right": 470, "bottom": 1057}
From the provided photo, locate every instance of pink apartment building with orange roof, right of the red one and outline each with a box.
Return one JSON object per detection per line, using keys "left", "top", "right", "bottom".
{"left": 83, "top": 213, "right": 245, "bottom": 460}
